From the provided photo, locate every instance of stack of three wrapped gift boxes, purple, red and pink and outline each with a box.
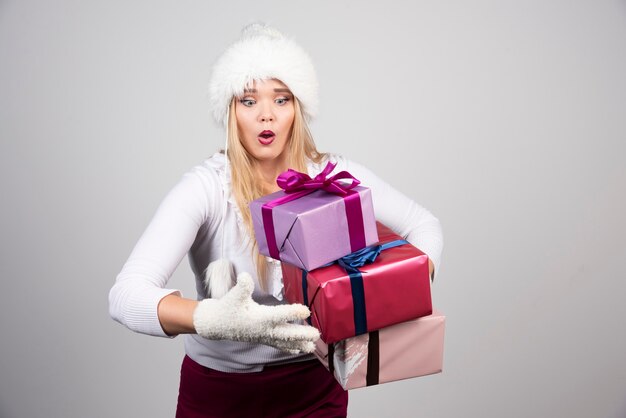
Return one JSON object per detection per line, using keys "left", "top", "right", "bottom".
{"left": 250, "top": 163, "right": 445, "bottom": 389}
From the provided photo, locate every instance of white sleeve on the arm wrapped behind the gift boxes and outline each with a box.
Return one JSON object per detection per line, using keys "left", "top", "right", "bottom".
{"left": 331, "top": 156, "right": 443, "bottom": 272}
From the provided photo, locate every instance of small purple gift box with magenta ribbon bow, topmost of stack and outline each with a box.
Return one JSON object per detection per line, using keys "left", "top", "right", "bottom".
{"left": 250, "top": 164, "right": 378, "bottom": 270}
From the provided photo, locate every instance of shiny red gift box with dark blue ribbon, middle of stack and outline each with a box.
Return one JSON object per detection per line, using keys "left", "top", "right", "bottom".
{"left": 282, "top": 223, "right": 432, "bottom": 343}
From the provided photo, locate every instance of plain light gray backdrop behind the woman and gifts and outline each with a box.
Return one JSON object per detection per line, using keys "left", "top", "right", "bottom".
{"left": 0, "top": 0, "right": 626, "bottom": 418}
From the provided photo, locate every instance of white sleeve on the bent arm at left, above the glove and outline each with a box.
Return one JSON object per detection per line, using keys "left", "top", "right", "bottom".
{"left": 109, "top": 170, "right": 221, "bottom": 337}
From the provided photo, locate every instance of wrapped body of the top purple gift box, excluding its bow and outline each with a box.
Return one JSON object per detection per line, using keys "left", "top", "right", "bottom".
{"left": 250, "top": 186, "right": 378, "bottom": 270}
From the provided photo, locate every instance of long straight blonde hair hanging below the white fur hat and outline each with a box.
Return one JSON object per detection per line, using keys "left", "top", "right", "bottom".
{"left": 227, "top": 97, "right": 325, "bottom": 289}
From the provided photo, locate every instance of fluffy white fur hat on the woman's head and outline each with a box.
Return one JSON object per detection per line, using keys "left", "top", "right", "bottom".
{"left": 209, "top": 23, "right": 318, "bottom": 126}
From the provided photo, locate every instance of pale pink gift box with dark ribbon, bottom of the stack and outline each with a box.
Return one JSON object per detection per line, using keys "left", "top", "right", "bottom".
{"left": 314, "top": 310, "right": 445, "bottom": 390}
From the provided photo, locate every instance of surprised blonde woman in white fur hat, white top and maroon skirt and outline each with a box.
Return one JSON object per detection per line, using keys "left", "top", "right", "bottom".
{"left": 109, "top": 24, "right": 442, "bottom": 417}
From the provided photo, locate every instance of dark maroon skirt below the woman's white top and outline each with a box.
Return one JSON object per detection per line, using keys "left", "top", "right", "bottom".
{"left": 176, "top": 356, "right": 348, "bottom": 418}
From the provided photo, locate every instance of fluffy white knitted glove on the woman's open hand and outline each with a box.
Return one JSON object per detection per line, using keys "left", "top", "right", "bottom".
{"left": 193, "top": 273, "right": 320, "bottom": 354}
